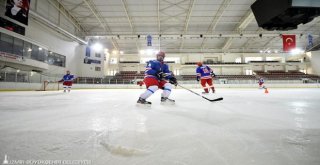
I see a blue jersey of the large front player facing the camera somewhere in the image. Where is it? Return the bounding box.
[144,60,172,79]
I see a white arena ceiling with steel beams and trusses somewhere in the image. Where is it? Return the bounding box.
[56,0,320,54]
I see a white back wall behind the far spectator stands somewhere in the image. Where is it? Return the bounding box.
[103,53,306,75]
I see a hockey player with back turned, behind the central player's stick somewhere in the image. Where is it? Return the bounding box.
[196,62,216,94]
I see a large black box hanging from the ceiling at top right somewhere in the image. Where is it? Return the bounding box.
[251,0,320,30]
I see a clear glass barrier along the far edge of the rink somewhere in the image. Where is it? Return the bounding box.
[0,70,320,84]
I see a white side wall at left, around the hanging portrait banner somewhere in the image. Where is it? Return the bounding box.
[0,0,79,74]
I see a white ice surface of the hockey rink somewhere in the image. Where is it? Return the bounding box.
[0,88,320,165]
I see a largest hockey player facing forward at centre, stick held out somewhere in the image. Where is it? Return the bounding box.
[137,51,177,104]
